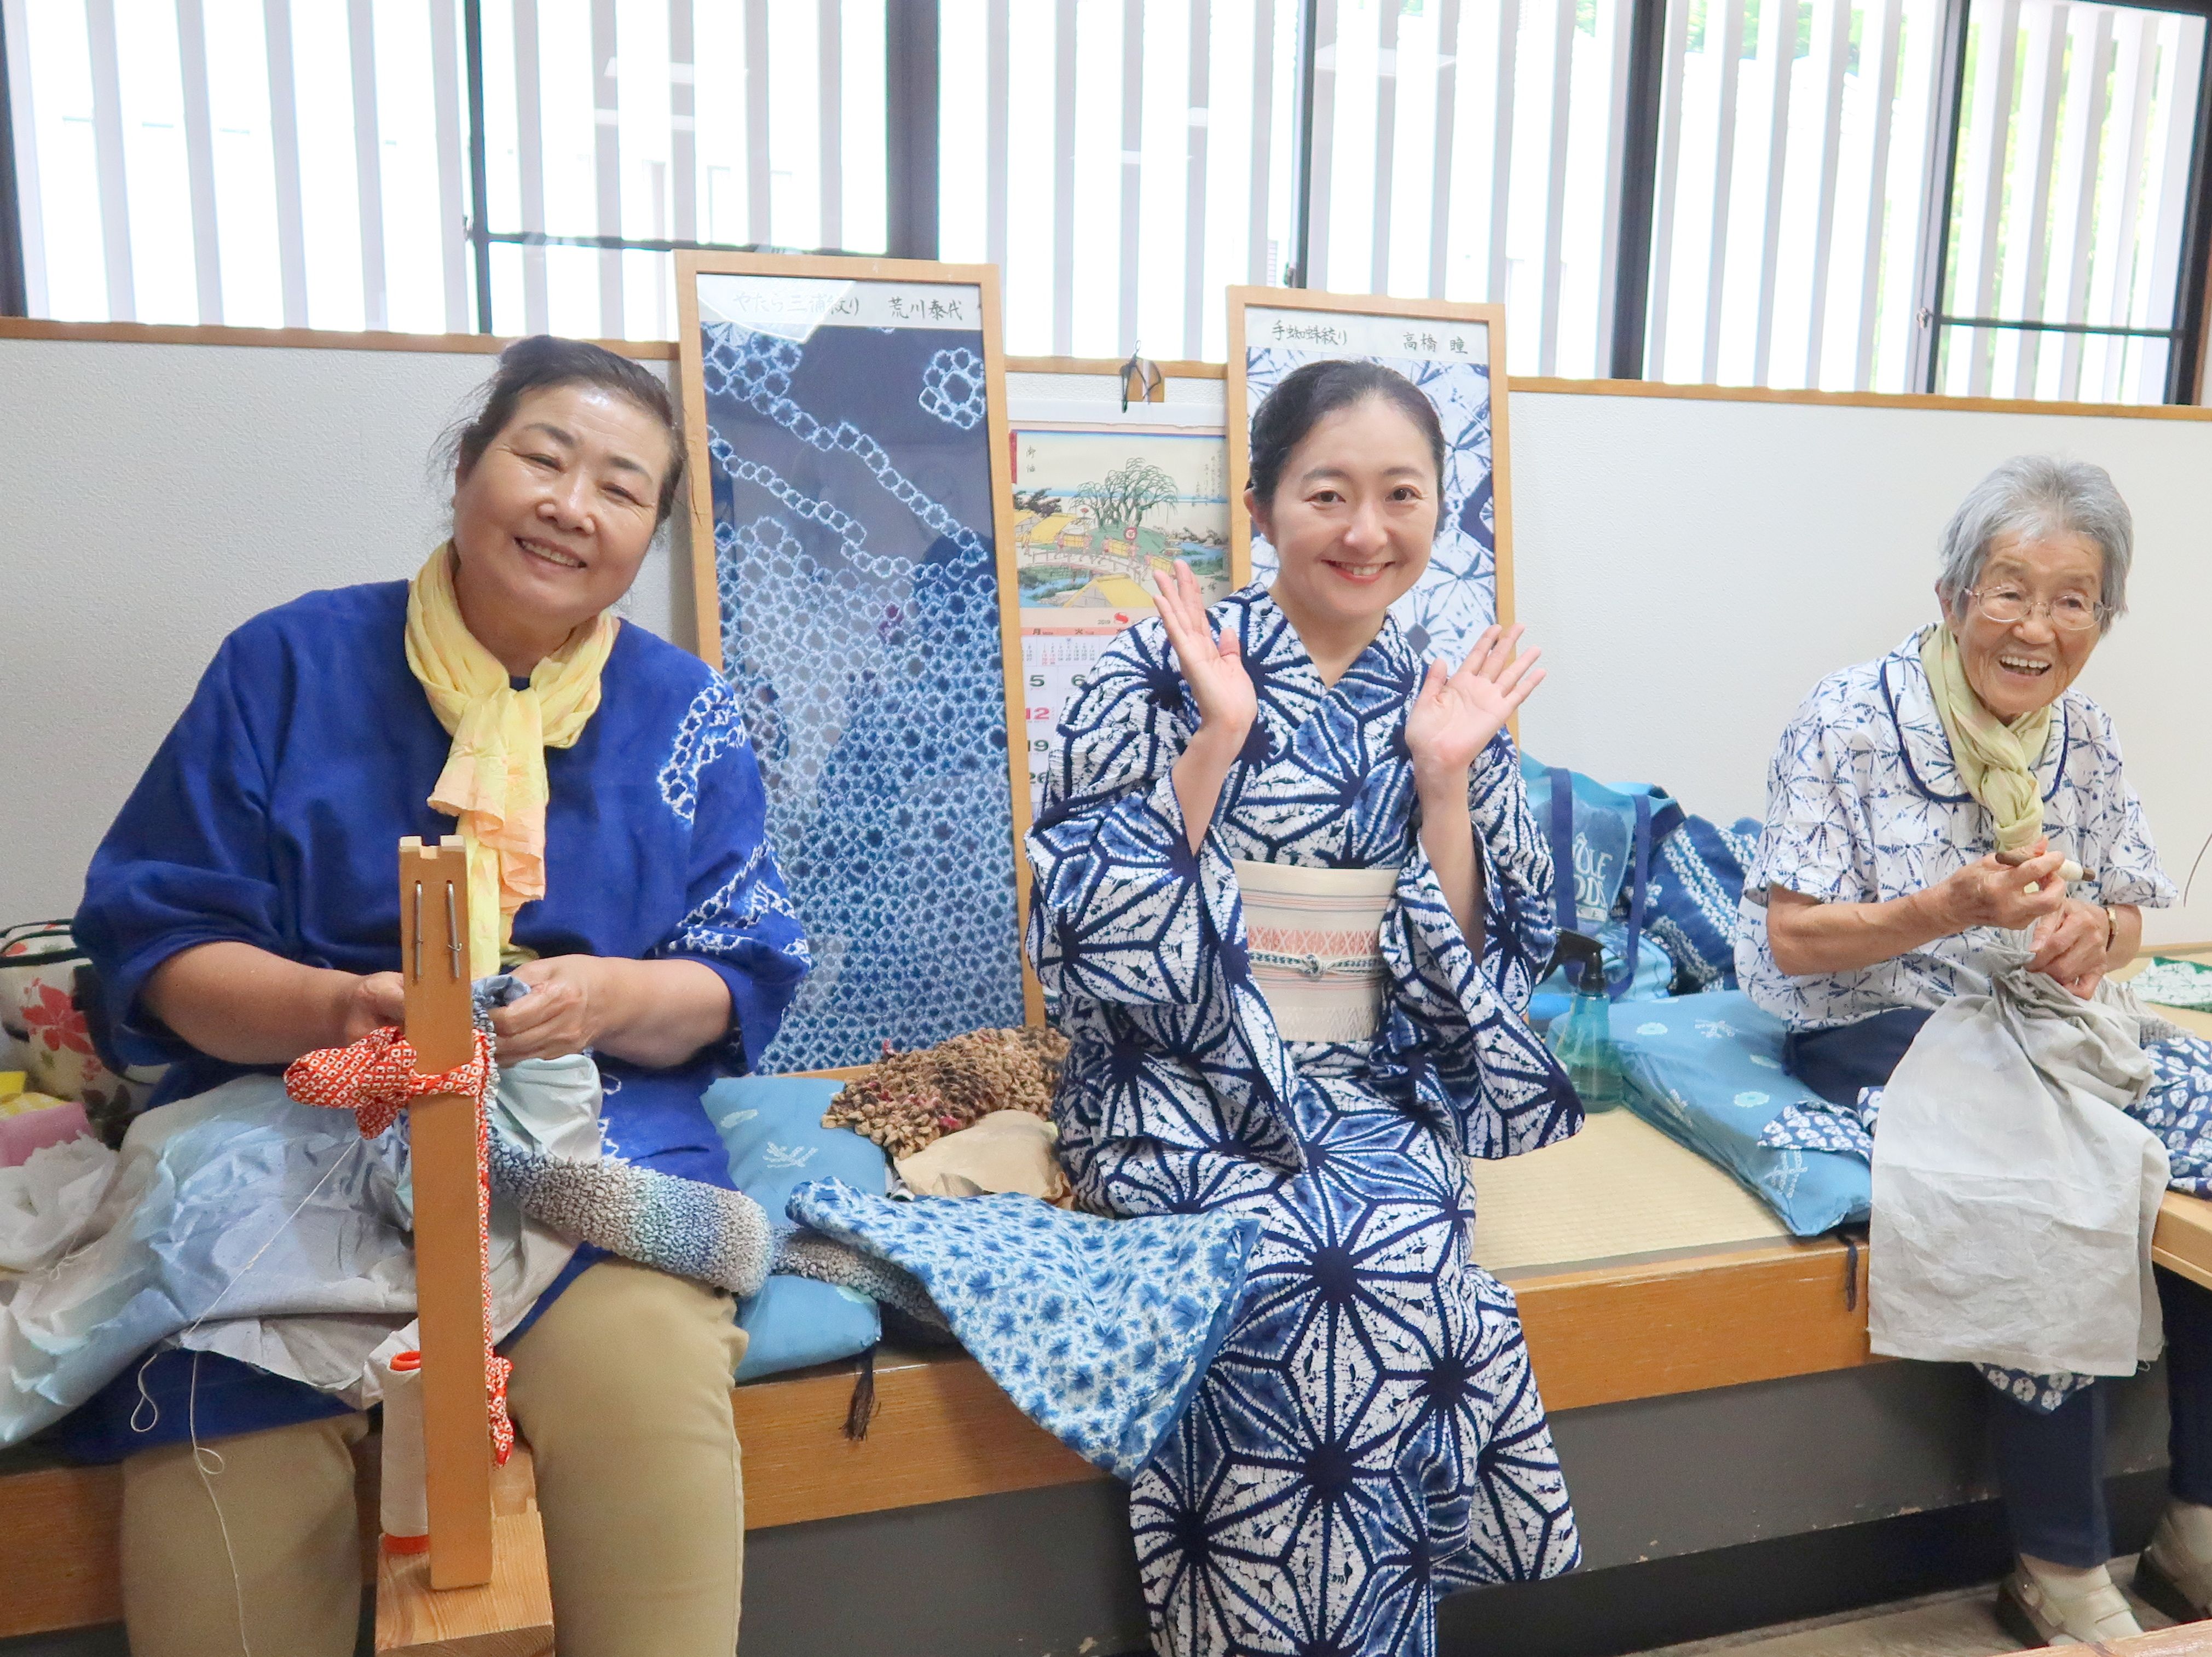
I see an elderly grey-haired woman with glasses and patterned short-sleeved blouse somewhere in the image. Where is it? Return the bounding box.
[1736,456,2212,1642]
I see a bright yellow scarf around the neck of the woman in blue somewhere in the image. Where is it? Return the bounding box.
[407,542,622,978]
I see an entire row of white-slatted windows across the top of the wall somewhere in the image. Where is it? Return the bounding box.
[0,0,2212,403]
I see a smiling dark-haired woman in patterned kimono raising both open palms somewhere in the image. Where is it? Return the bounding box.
[1029,363,1581,1657]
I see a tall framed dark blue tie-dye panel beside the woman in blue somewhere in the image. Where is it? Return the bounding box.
[677,252,1042,1071]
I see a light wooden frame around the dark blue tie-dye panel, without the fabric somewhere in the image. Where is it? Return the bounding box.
[677,252,1044,1026]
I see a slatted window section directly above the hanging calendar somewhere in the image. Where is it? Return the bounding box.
[938,0,1305,358]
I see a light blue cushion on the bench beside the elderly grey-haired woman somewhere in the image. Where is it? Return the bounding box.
[1613,989,1874,1237]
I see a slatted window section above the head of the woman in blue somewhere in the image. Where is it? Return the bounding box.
[473,0,885,339]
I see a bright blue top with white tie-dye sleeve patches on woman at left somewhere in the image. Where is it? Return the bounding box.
[77,582,807,1188]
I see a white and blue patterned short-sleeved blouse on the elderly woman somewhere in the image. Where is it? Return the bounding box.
[1736,633,2176,1029]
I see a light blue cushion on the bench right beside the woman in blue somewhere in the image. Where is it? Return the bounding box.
[703,1075,892,1381]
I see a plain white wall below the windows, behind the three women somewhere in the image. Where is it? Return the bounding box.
[0,341,2212,940]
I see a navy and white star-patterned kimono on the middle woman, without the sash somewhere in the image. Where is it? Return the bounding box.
[1029,586,1581,1657]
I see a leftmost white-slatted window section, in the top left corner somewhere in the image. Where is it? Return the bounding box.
[0,0,471,332]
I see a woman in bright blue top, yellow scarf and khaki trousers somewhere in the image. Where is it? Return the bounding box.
[73,339,805,1657]
